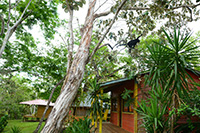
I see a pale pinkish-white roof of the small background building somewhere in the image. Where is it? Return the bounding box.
[20,99,54,106]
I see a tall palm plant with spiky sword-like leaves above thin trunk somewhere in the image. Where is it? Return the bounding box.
[142,28,200,132]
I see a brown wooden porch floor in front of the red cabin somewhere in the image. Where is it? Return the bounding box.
[92,122,130,133]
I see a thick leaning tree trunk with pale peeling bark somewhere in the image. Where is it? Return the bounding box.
[42,0,96,133]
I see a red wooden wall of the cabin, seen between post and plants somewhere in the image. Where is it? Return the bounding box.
[110,71,200,133]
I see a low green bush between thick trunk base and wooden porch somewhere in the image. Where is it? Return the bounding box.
[66,117,92,133]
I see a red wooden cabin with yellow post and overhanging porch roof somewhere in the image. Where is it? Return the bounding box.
[101,70,200,133]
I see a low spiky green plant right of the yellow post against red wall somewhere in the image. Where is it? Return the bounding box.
[137,88,173,132]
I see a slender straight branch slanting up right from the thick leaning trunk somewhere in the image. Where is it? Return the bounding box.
[86,0,127,63]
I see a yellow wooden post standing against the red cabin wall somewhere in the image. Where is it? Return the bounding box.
[134,79,138,133]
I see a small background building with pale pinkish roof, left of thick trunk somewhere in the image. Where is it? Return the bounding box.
[20,99,54,120]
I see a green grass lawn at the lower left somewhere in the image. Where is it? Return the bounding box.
[3,120,45,133]
